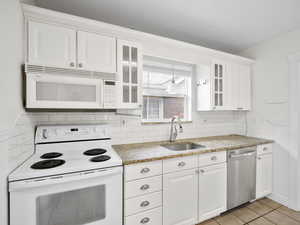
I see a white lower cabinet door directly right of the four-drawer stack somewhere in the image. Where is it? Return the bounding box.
[163,169,198,225]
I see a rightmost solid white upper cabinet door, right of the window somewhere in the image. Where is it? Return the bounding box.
[237,65,251,110]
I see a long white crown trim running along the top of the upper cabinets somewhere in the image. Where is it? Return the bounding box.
[22,4,254,64]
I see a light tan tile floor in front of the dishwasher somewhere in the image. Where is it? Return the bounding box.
[198,198,300,225]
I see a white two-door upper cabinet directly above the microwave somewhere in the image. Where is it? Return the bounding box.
[28,21,116,73]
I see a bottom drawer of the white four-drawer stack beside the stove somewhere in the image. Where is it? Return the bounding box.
[125,207,162,225]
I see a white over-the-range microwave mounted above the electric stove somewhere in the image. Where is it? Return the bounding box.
[26,71,117,109]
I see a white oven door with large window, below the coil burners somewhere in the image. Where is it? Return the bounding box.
[9,167,122,225]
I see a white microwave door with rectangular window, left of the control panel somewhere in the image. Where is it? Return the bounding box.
[26,74,103,109]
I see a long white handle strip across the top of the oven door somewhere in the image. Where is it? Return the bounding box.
[9,166,123,192]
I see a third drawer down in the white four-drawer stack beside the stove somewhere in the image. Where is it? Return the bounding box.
[125,191,162,216]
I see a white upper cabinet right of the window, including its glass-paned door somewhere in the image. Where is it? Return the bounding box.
[197,61,251,111]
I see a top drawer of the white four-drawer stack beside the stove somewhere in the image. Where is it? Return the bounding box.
[125,161,162,181]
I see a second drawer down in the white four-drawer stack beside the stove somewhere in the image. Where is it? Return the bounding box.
[125,175,162,199]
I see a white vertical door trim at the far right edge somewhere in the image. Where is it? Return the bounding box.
[288,53,300,210]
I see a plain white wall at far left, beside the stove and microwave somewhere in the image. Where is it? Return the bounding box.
[0,0,23,225]
